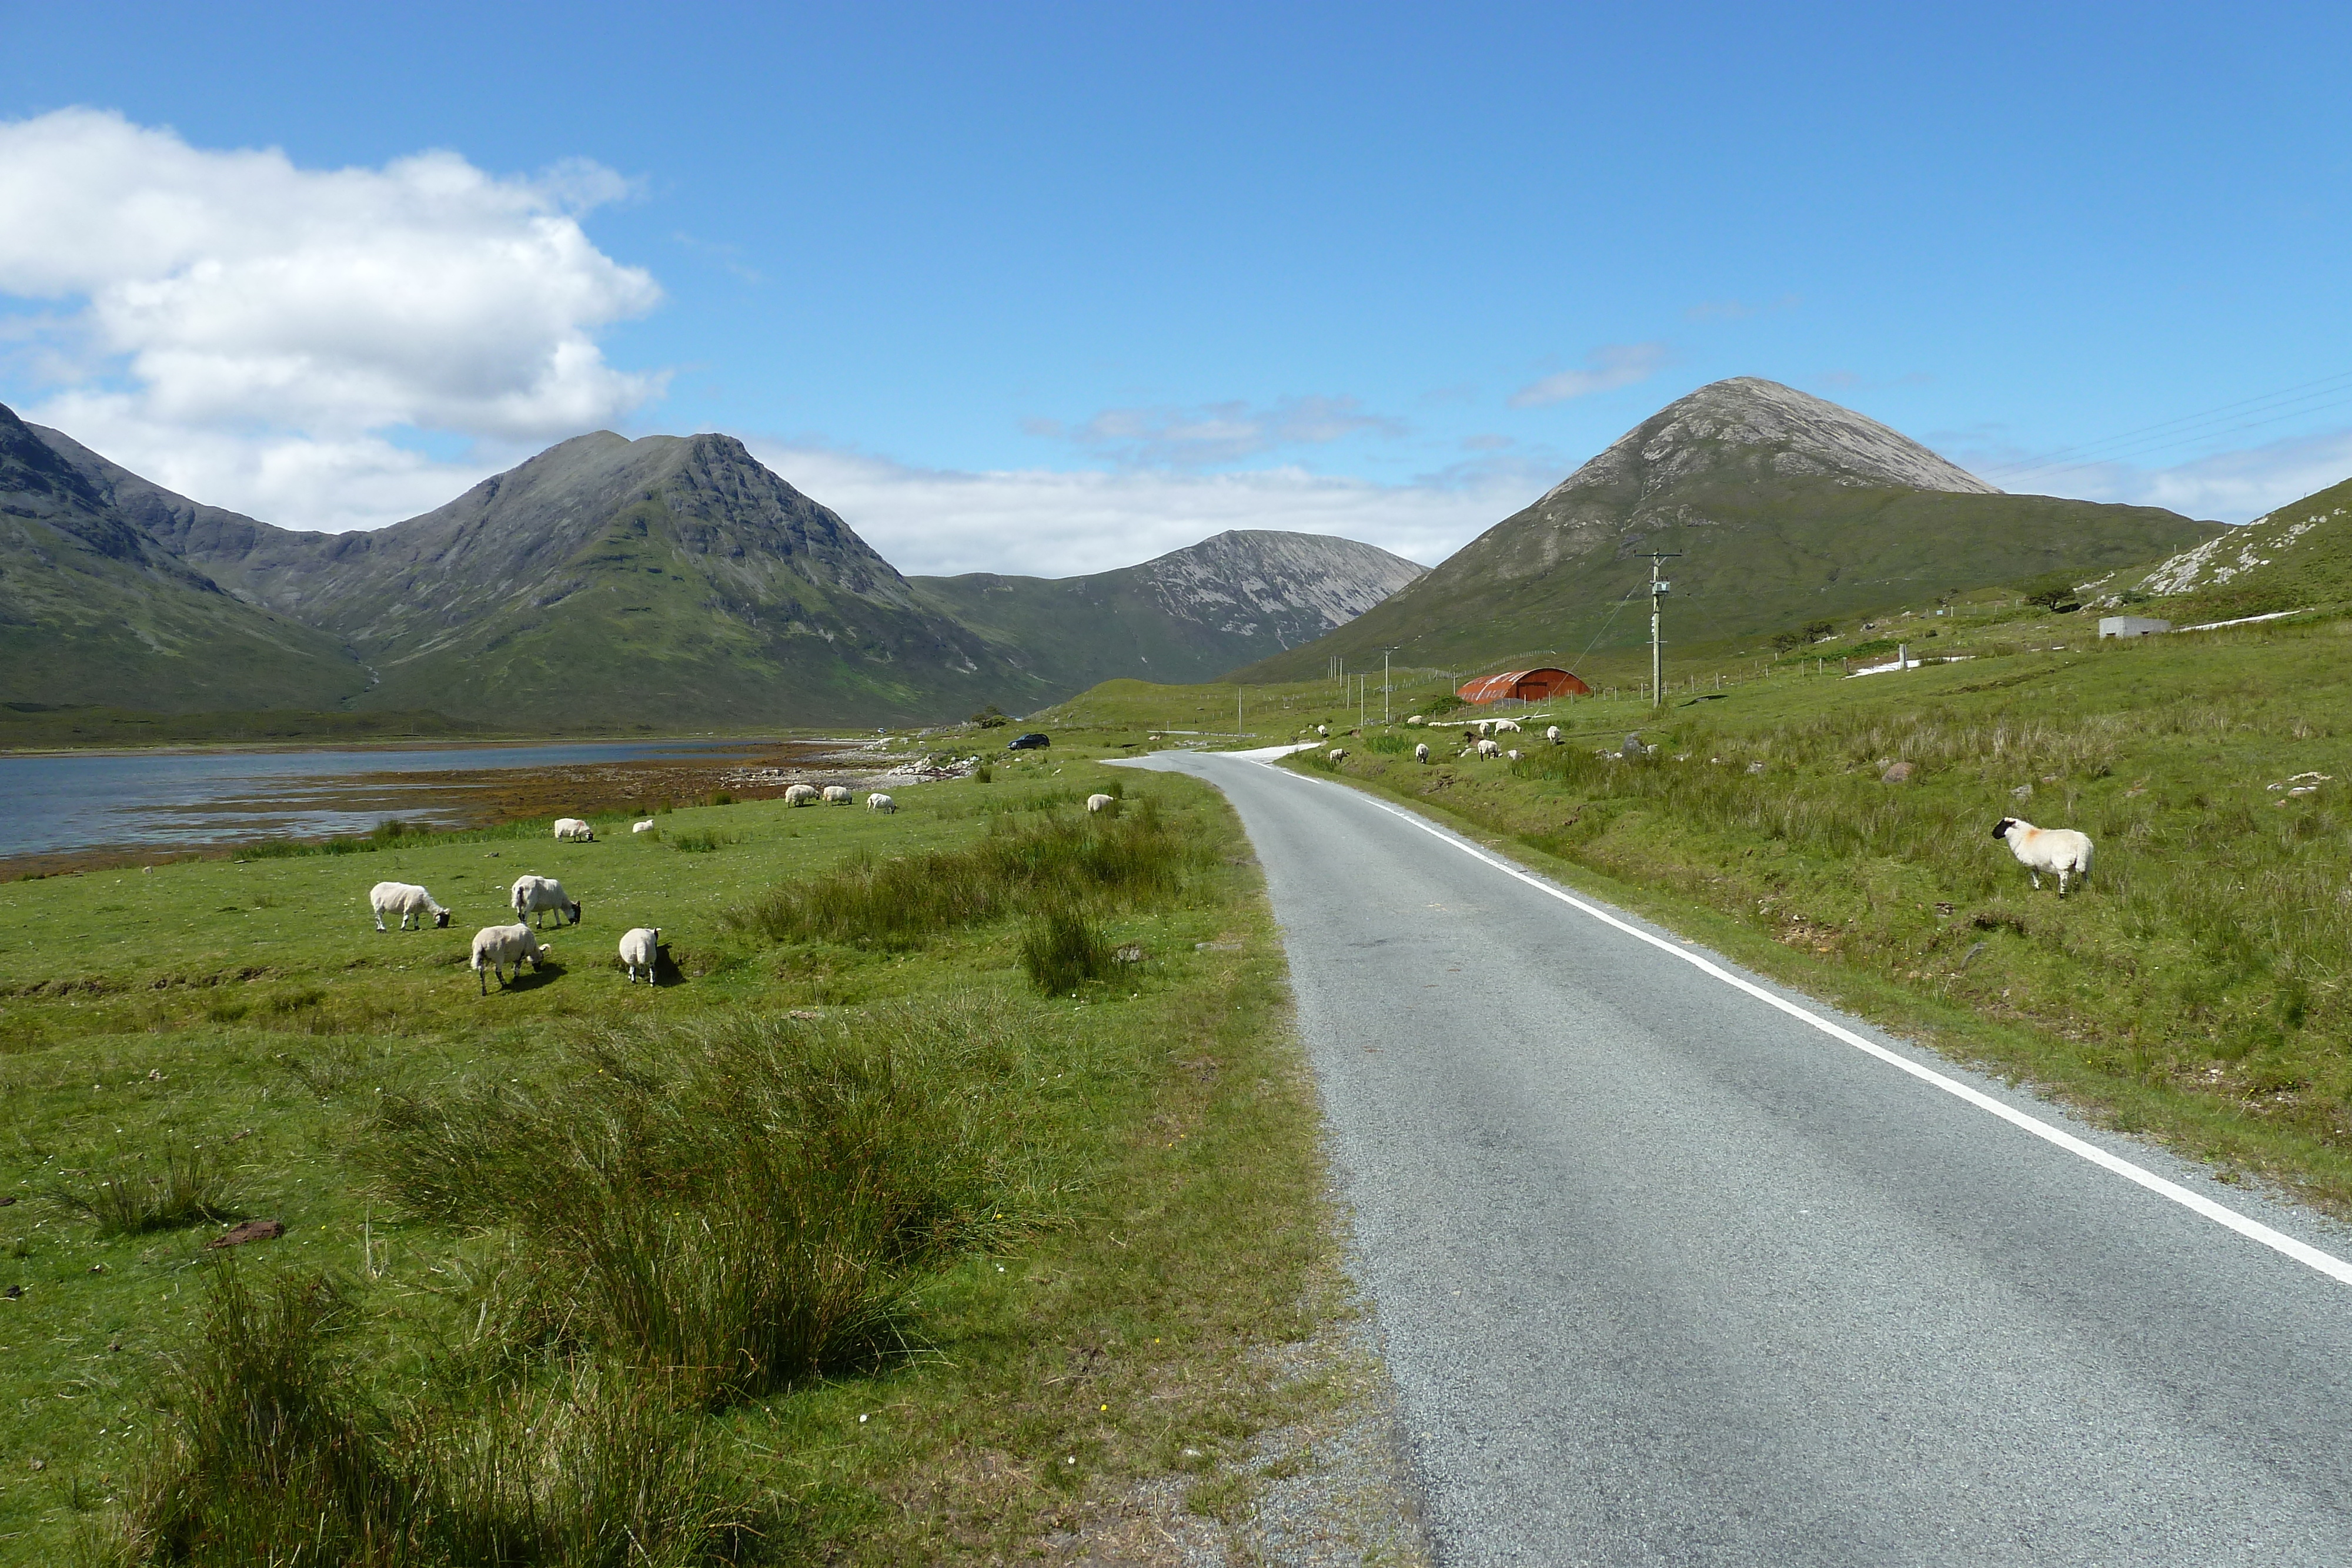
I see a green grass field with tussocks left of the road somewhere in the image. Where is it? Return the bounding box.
[0,761,1374,1563]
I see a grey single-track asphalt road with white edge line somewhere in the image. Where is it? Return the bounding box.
[1129,755,2352,1568]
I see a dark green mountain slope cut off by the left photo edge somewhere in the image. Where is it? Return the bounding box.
[0,407,367,713]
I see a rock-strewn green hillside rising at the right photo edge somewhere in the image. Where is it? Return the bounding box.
[2105,480,2352,623]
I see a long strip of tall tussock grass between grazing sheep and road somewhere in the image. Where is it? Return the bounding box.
[727,797,1200,947]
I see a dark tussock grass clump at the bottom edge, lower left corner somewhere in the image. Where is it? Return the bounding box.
[99,1262,764,1568]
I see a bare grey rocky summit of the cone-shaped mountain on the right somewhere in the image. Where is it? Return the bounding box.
[1538,376,2002,506]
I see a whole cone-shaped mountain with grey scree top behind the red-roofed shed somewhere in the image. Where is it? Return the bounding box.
[1235,376,2223,682]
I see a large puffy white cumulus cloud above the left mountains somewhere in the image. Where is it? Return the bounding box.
[0,108,661,527]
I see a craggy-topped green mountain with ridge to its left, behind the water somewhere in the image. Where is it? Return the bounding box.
[28,433,1047,729]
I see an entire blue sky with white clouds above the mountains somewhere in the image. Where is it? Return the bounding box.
[0,2,2352,574]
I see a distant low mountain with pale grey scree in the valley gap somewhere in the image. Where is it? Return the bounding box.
[908,529,1428,696]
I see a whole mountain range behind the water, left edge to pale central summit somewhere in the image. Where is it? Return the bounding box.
[0,409,1421,731]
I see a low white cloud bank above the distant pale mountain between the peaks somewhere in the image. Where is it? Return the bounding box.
[750,440,1557,576]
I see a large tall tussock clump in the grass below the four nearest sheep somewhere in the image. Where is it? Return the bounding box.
[379,1001,1018,1406]
